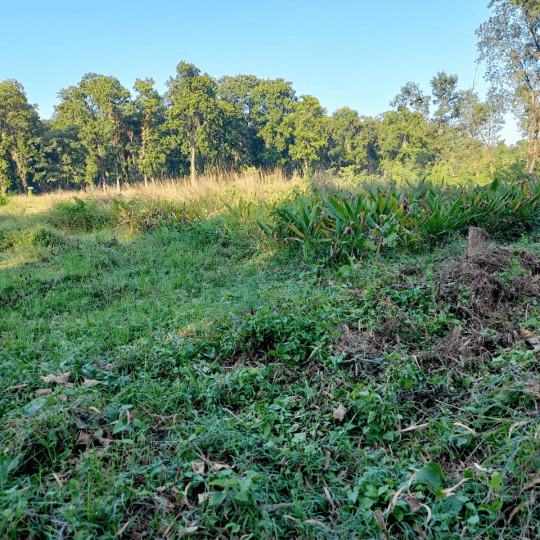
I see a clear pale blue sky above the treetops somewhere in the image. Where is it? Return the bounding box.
[0,0,521,144]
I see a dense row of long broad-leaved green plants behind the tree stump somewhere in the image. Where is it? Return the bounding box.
[259,179,540,259]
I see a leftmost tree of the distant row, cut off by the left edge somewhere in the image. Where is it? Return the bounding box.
[0,79,41,191]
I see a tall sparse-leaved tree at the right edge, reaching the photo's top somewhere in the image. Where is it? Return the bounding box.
[476,0,540,174]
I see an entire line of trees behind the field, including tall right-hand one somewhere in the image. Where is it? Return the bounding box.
[0,0,540,192]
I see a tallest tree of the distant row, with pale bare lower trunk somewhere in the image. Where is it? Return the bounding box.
[167,61,220,185]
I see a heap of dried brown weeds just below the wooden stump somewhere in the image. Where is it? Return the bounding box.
[419,248,540,364]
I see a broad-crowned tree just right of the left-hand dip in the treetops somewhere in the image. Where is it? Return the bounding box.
[55,73,130,188]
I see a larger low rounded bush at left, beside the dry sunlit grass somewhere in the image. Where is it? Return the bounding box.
[48,197,114,232]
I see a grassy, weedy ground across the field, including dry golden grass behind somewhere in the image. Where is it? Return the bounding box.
[0,177,540,540]
